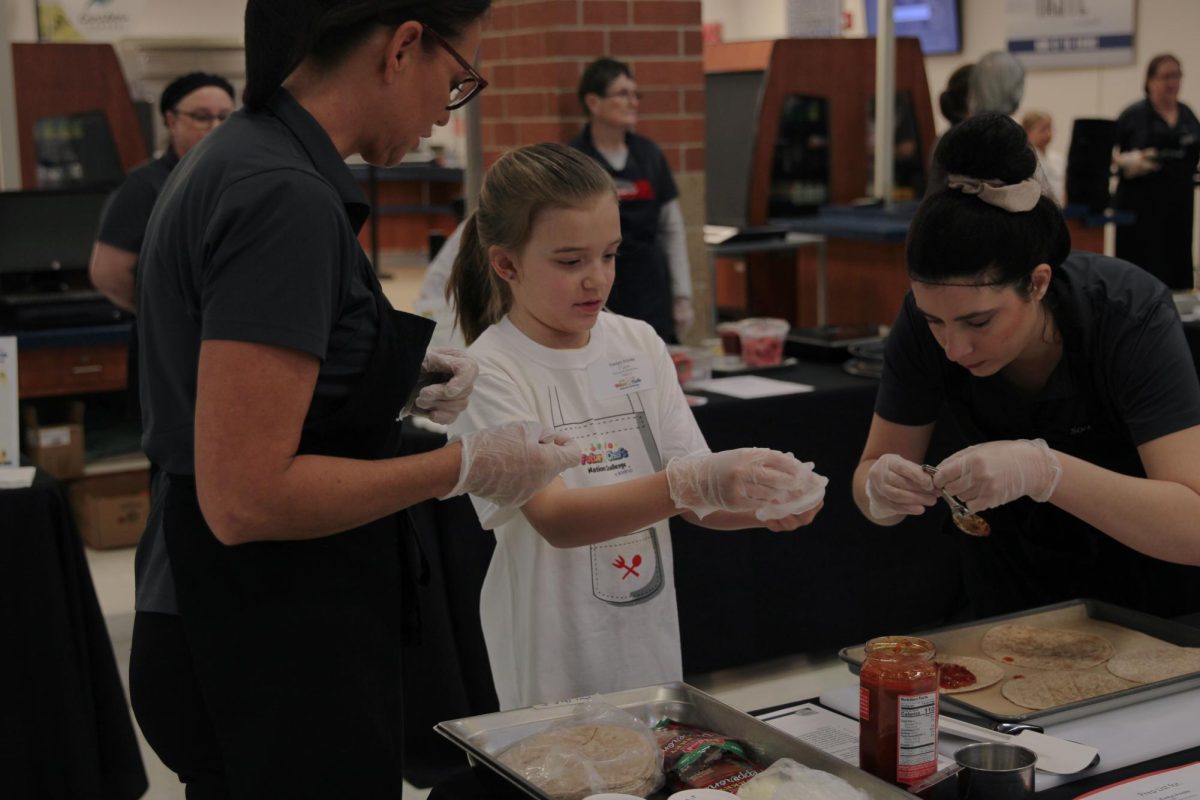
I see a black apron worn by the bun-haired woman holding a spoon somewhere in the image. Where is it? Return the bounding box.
[944,354,1200,619]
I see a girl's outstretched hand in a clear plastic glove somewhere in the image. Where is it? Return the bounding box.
[666,447,815,519]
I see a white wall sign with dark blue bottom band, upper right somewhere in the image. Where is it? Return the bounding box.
[1007,0,1136,68]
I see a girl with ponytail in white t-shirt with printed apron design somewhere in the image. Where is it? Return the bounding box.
[448,144,826,709]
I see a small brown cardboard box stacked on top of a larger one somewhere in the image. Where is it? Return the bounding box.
[68,469,150,549]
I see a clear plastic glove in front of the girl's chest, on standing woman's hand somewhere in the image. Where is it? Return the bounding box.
[440,422,583,509]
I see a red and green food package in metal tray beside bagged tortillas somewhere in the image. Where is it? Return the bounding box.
[655,720,760,793]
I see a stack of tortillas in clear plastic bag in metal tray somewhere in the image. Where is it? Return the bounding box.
[499,724,660,800]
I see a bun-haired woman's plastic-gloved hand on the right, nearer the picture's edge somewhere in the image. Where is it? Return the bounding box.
[934,439,1062,511]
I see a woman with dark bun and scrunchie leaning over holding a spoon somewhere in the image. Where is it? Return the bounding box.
[853,114,1200,615]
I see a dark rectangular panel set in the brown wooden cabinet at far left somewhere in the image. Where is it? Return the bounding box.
[34,110,125,188]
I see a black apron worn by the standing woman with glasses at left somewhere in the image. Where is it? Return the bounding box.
[163,282,433,799]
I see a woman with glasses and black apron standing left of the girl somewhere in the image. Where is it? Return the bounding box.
[130,0,580,800]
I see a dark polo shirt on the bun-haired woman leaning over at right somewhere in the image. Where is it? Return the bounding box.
[875,252,1200,476]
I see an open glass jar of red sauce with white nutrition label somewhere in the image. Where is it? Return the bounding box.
[858,636,937,786]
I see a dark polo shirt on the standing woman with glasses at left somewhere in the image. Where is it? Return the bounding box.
[138,89,378,475]
